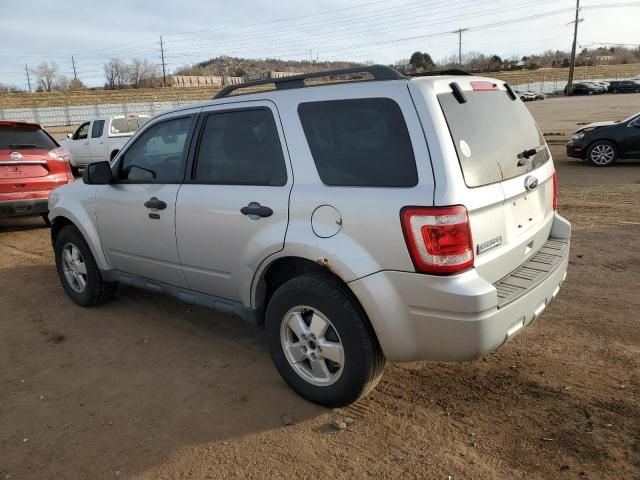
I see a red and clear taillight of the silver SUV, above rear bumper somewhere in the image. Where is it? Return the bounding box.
[400,205,474,275]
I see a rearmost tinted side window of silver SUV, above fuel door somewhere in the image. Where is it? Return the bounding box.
[298,98,418,187]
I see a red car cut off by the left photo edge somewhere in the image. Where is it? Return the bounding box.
[0,121,73,224]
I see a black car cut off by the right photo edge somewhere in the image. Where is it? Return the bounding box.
[567,113,640,167]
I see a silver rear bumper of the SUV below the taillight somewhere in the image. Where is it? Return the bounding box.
[349,215,570,362]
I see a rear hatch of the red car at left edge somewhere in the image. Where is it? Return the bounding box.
[0,122,65,194]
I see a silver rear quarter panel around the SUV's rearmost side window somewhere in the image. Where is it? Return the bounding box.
[251,81,434,305]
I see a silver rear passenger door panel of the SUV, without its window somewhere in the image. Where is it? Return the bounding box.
[176,100,293,307]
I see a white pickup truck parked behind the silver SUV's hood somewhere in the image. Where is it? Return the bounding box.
[60,114,149,176]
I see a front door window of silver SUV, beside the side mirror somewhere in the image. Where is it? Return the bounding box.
[118,117,192,183]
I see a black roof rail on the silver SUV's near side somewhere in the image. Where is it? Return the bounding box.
[213,65,406,99]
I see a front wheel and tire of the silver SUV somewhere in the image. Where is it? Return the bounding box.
[54,225,115,307]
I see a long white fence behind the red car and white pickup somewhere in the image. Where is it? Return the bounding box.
[0,100,203,127]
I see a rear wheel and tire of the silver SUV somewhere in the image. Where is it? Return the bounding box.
[265,274,385,407]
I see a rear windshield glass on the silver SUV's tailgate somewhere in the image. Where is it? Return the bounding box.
[438,90,550,187]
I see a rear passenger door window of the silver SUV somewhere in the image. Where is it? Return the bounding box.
[195,108,287,186]
